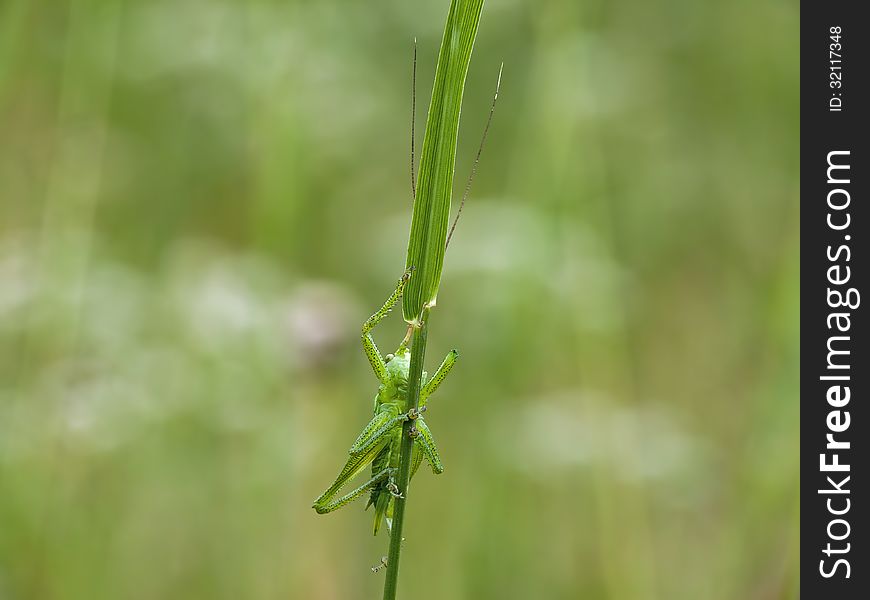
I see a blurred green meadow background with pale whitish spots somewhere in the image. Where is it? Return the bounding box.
[0,0,799,600]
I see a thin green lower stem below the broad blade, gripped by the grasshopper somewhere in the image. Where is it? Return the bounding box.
[384,308,429,600]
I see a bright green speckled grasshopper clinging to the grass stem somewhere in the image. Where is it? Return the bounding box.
[314,269,459,535]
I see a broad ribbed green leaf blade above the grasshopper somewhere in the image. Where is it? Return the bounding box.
[402,0,483,322]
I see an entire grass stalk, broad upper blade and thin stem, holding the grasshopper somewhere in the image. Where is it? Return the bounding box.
[384,0,483,600]
